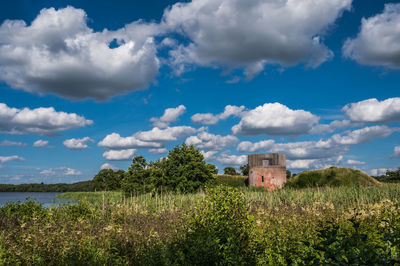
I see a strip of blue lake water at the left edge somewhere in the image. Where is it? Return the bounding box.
[0,192,71,207]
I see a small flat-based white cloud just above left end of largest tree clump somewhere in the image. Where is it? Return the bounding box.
[98,133,162,149]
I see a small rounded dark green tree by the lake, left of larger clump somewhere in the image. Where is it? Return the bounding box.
[92,169,125,190]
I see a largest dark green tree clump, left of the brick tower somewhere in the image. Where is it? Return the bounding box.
[122,143,213,193]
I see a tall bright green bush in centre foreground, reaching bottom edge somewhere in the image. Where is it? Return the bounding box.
[174,186,255,265]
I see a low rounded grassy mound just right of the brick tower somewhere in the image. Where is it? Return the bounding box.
[286,167,379,188]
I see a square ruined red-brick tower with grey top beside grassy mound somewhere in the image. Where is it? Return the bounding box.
[248,153,286,190]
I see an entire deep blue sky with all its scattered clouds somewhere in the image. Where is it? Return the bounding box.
[0,0,400,184]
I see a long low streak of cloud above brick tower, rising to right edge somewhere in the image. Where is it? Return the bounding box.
[237,126,399,160]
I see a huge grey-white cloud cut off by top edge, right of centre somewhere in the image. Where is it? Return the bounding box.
[163,0,352,78]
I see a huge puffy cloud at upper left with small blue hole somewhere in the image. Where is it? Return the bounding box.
[0,6,161,101]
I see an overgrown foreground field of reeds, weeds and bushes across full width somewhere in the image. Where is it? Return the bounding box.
[0,184,400,265]
